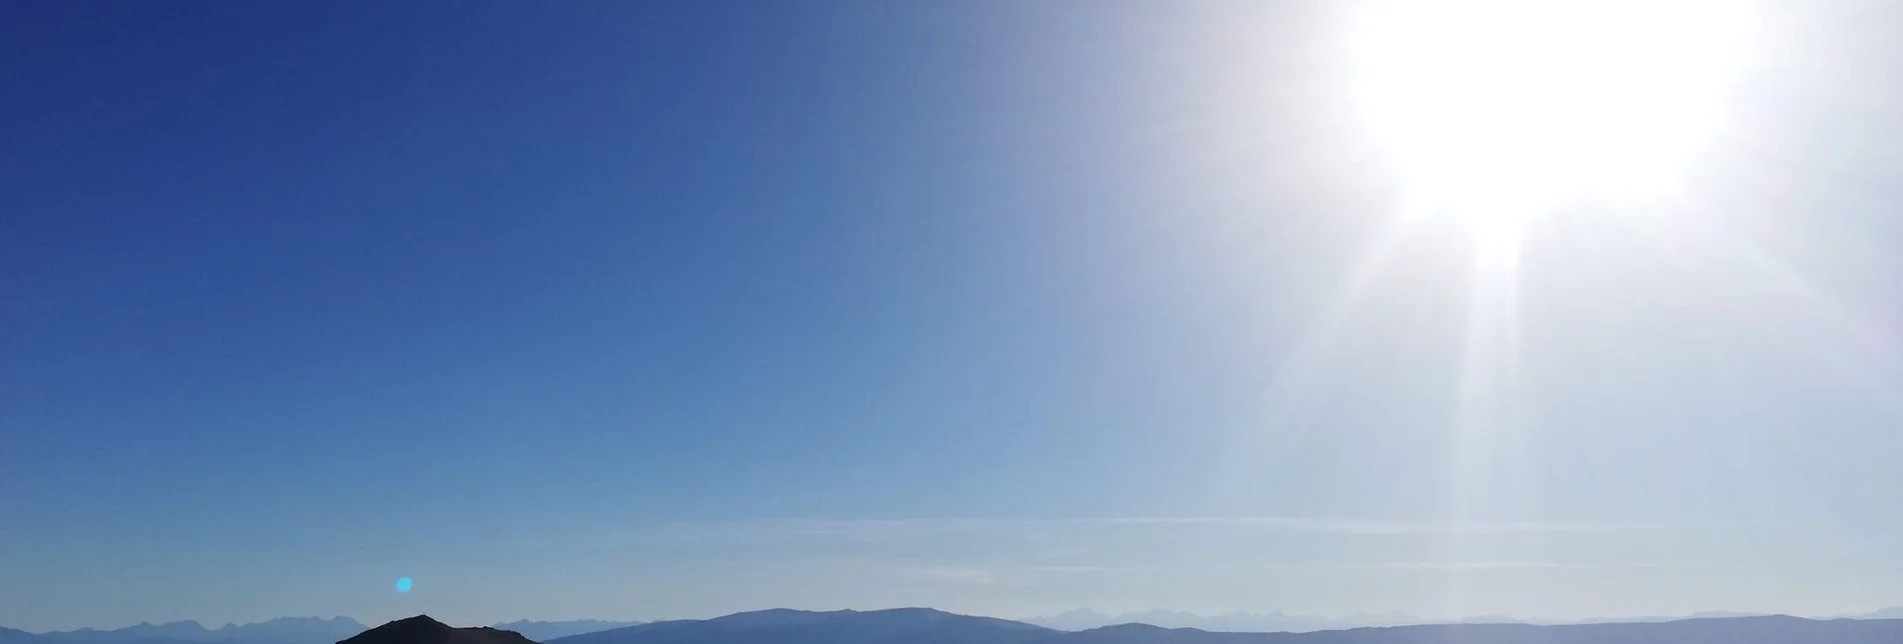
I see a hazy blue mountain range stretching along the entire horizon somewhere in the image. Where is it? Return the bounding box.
[11,608,1903,644]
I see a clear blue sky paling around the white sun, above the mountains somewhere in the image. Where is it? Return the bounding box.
[0,0,1903,631]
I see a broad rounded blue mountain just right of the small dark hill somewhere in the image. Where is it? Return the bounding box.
[554,608,1056,644]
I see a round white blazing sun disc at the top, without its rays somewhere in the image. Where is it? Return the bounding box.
[1355,0,1747,234]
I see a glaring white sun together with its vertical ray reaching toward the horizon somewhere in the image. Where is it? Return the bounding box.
[1353,0,1751,586]
